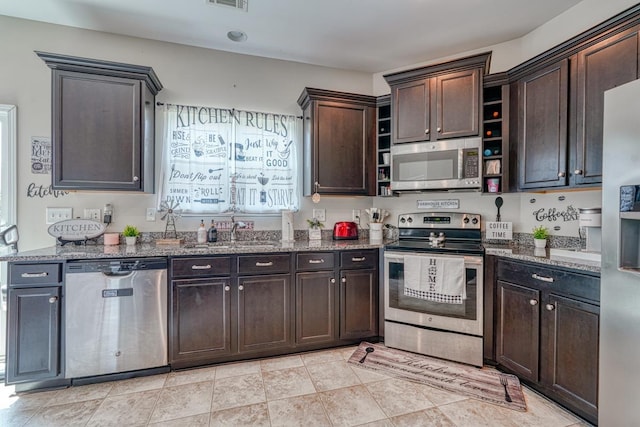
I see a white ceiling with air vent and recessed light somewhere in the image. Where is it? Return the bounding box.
[0,0,580,73]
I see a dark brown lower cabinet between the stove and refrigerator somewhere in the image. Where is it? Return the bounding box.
[494,259,600,424]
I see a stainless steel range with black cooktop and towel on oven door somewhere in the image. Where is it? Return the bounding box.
[384,212,484,366]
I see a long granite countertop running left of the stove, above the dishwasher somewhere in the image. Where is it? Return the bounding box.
[0,239,387,262]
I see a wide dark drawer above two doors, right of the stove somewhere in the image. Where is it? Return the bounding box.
[497,260,600,303]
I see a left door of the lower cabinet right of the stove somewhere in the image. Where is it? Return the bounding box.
[495,280,540,382]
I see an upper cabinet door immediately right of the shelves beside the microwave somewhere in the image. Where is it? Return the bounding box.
[518,60,569,189]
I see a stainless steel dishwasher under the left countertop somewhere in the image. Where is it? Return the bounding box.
[65,258,168,378]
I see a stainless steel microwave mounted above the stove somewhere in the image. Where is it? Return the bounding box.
[391,138,482,191]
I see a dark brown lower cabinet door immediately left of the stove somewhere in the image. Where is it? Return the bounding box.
[340,269,378,339]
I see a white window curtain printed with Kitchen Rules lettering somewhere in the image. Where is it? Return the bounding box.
[159,105,299,213]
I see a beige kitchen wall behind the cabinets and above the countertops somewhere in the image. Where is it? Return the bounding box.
[0,0,634,250]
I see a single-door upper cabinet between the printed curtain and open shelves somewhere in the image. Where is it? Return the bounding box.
[298,88,376,196]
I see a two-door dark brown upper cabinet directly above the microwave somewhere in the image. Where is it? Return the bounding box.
[384,53,491,144]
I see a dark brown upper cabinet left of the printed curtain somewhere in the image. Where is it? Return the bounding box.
[36,52,162,193]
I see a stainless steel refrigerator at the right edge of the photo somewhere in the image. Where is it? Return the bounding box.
[604,77,640,426]
